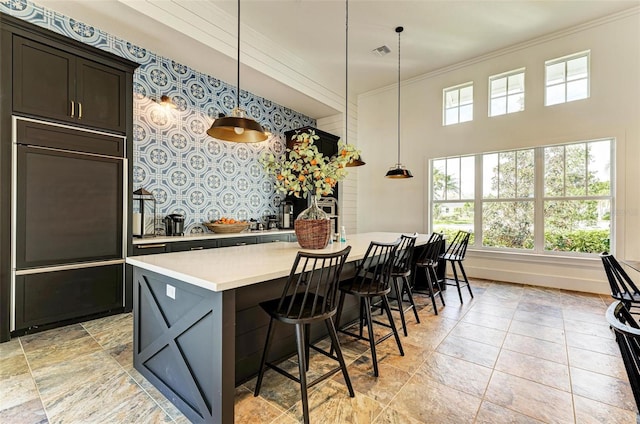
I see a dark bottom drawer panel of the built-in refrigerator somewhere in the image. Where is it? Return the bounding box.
[15,264,124,332]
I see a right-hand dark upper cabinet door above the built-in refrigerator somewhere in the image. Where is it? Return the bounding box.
[75,58,127,132]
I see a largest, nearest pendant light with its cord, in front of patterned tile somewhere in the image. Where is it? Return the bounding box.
[207,0,268,143]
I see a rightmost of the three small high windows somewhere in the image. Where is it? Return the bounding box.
[544,51,589,106]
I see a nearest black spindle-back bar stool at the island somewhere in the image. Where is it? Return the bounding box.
[254,246,355,424]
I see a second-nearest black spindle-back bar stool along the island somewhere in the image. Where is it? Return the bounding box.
[336,239,404,377]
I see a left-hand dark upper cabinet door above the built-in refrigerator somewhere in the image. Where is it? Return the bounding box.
[13,36,75,122]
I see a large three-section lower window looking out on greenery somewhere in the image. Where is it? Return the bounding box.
[431,139,614,254]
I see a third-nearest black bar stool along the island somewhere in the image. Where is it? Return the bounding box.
[384,233,420,336]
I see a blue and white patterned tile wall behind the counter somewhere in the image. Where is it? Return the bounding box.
[0,0,316,233]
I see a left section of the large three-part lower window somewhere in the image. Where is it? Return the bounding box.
[431,156,475,242]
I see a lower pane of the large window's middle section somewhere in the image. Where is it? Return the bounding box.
[482,201,533,250]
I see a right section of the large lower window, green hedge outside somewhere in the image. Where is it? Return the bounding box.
[544,140,611,253]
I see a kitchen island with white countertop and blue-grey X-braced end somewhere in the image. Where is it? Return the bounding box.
[127,233,427,424]
